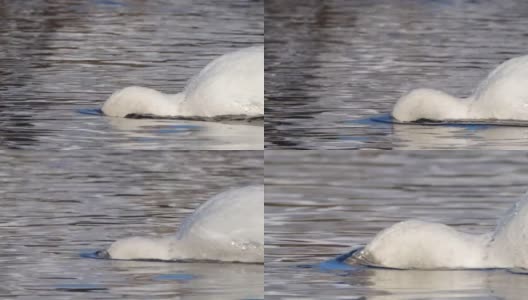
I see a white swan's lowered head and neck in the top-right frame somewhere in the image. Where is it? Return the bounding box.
[392,89,469,122]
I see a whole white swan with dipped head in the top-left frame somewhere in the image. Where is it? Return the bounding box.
[101,46,264,117]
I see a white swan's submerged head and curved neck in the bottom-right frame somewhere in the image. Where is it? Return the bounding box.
[353,220,490,269]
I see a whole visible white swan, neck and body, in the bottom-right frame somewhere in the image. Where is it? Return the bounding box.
[350,194,528,269]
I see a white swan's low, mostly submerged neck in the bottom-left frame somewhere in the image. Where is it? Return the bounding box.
[105,237,170,260]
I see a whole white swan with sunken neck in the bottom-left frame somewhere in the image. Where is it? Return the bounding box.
[96,185,264,263]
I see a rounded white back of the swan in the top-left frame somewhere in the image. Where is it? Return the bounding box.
[184,46,264,116]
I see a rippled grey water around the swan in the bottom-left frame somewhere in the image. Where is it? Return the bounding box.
[0,150,264,299]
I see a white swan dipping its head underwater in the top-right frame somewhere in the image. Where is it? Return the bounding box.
[392,55,528,122]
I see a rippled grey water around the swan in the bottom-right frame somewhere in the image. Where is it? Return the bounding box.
[265,151,528,300]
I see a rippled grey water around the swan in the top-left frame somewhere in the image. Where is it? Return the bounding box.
[0,0,264,151]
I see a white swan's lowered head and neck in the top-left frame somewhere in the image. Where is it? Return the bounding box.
[101,86,184,117]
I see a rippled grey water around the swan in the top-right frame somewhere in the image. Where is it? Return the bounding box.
[265,0,528,149]
